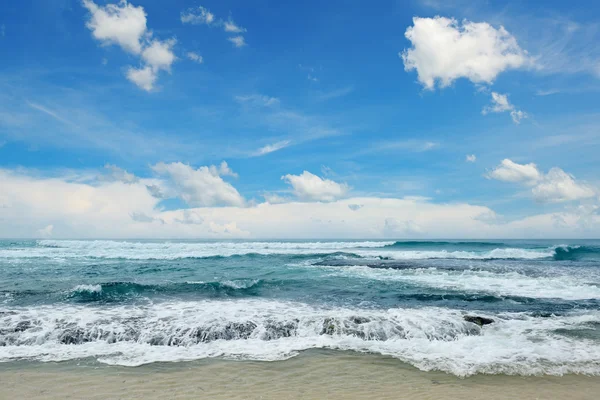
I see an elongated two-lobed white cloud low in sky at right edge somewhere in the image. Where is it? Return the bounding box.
[488,159,596,203]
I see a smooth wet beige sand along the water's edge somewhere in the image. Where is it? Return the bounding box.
[0,351,600,400]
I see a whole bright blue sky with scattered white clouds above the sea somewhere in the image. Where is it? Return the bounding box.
[0,0,600,239]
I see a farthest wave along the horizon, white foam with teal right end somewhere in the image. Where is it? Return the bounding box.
[0,240,600,261]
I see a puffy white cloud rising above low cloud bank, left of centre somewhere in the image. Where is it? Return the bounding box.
[152,162,245,206]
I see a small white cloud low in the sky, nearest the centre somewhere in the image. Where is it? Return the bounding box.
[281,171,350,201]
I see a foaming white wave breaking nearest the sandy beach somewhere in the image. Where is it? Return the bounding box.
[0,300,600,376]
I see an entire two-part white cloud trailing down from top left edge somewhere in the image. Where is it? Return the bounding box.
[83,0,177,92]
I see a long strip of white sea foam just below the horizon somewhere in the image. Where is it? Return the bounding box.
[0,240,555,260]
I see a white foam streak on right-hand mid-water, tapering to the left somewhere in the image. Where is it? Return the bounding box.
[310,265,600,300]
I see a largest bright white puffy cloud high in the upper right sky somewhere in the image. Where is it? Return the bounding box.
[400,17,532,90]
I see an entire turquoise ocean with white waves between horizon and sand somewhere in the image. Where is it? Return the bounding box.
[0,240,600,377]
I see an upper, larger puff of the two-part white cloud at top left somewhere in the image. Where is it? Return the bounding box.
[83,0,146,54]
